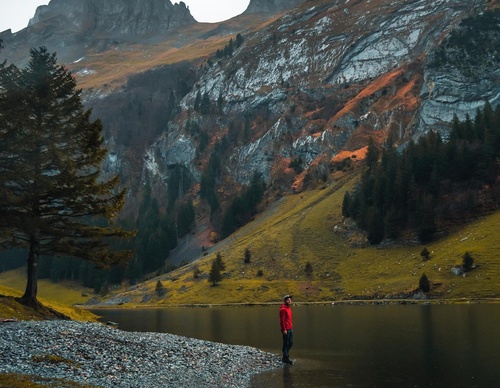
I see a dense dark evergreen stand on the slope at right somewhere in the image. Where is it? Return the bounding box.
[342,103,500,244]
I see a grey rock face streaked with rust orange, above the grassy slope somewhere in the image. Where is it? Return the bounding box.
[147,0,492,191]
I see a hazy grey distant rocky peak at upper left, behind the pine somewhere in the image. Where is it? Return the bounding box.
[1,0,196,62]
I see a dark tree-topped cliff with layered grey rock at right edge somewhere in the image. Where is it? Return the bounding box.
[417,9,500,136]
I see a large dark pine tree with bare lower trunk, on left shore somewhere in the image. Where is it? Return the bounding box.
[0,47,131,305]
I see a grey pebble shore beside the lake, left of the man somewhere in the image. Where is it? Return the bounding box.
[0,321,282,388]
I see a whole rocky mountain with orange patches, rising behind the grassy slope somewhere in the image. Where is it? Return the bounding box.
[0,0,500,296]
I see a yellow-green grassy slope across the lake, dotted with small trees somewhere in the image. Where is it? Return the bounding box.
[95,174,500,306]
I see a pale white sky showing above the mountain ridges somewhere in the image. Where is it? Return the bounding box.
[0,0,250,32]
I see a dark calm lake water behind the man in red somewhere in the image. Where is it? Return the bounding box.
[90,304,500,388]
